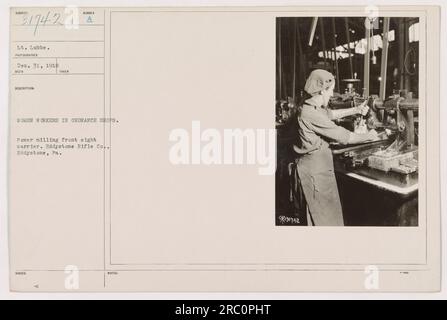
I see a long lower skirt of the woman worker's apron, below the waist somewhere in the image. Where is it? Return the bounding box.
[296,145,344,226]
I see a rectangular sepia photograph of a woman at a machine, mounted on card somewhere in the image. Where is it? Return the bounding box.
[275,16,423,227]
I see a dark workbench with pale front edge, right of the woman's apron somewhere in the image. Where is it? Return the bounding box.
[334,152,418,226]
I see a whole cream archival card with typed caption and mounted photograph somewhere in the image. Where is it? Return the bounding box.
[8,6,441,292]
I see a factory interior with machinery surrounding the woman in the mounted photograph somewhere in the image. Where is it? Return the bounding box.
[275,17,423,226]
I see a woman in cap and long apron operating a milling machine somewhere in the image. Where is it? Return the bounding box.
[293,69,377,226]
